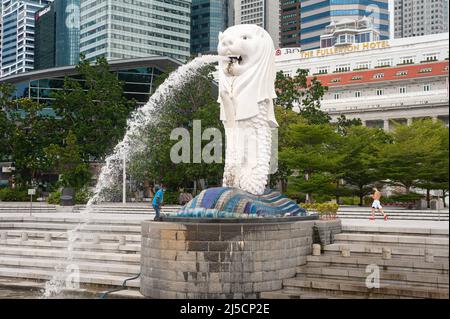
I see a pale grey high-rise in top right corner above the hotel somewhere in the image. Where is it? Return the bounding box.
[394,0,448,38]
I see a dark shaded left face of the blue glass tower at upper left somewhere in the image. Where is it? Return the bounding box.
[34,3,56,70]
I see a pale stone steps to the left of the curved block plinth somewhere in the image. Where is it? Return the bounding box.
[0,213,146,298]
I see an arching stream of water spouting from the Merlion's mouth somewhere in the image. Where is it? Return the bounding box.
[42,55,219,298]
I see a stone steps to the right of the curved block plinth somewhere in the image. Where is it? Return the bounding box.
[268,221,449,299]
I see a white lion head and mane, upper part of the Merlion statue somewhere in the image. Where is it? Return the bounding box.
[217,24,277,126]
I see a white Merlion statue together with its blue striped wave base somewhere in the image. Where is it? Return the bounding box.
[171,24,307,218]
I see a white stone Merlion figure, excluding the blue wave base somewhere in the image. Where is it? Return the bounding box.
[217,24,278,195]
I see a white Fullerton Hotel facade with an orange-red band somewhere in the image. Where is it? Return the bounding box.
[276,33,449,130]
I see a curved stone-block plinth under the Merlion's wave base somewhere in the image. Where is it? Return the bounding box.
[141,217,314,299]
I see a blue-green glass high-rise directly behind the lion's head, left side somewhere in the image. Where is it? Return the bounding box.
[191,0,229,54]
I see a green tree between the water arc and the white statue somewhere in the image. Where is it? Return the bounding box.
[130,66,224,194]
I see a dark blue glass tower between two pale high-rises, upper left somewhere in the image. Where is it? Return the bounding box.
[34,0,80,69]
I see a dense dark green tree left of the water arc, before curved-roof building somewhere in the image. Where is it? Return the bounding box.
[52,57,136,161]
